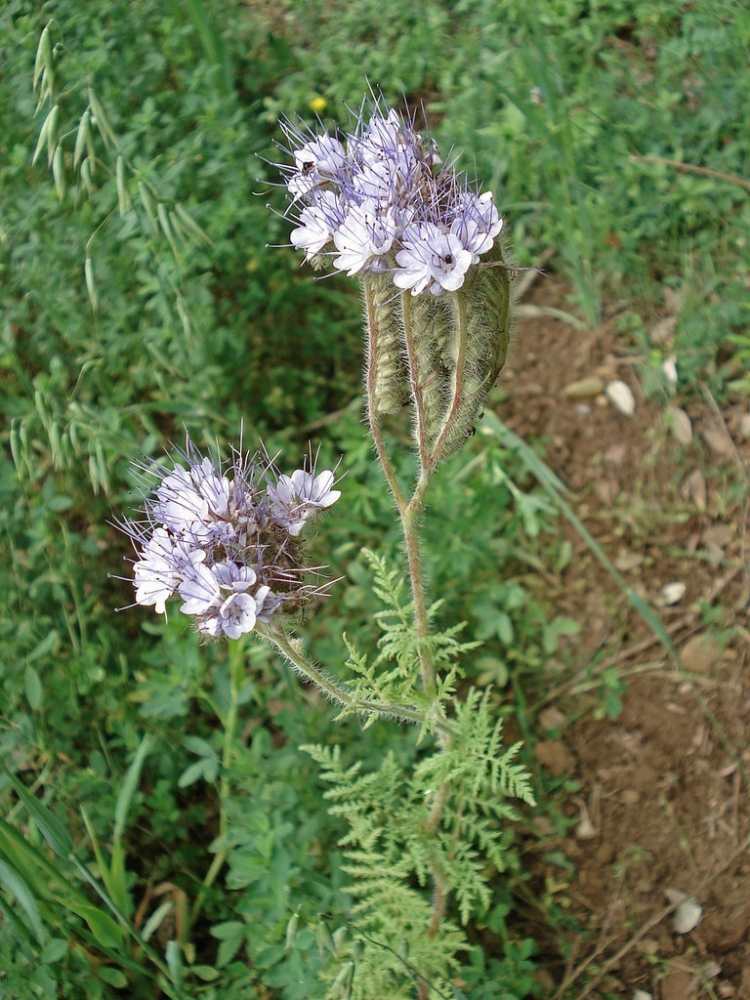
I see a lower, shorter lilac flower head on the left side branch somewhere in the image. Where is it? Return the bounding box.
[118,441,341,639]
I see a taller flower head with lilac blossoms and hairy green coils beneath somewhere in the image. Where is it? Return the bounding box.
[280,101,510,464]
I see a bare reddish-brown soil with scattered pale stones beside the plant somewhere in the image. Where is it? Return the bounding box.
[501,277,750,1000]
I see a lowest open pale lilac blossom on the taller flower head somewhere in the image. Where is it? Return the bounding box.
[393,222,474,295]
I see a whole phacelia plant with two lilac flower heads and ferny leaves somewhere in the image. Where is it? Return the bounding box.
[114,103,533,1000]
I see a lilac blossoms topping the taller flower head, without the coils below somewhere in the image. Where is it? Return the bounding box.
[280,107,503,295]
